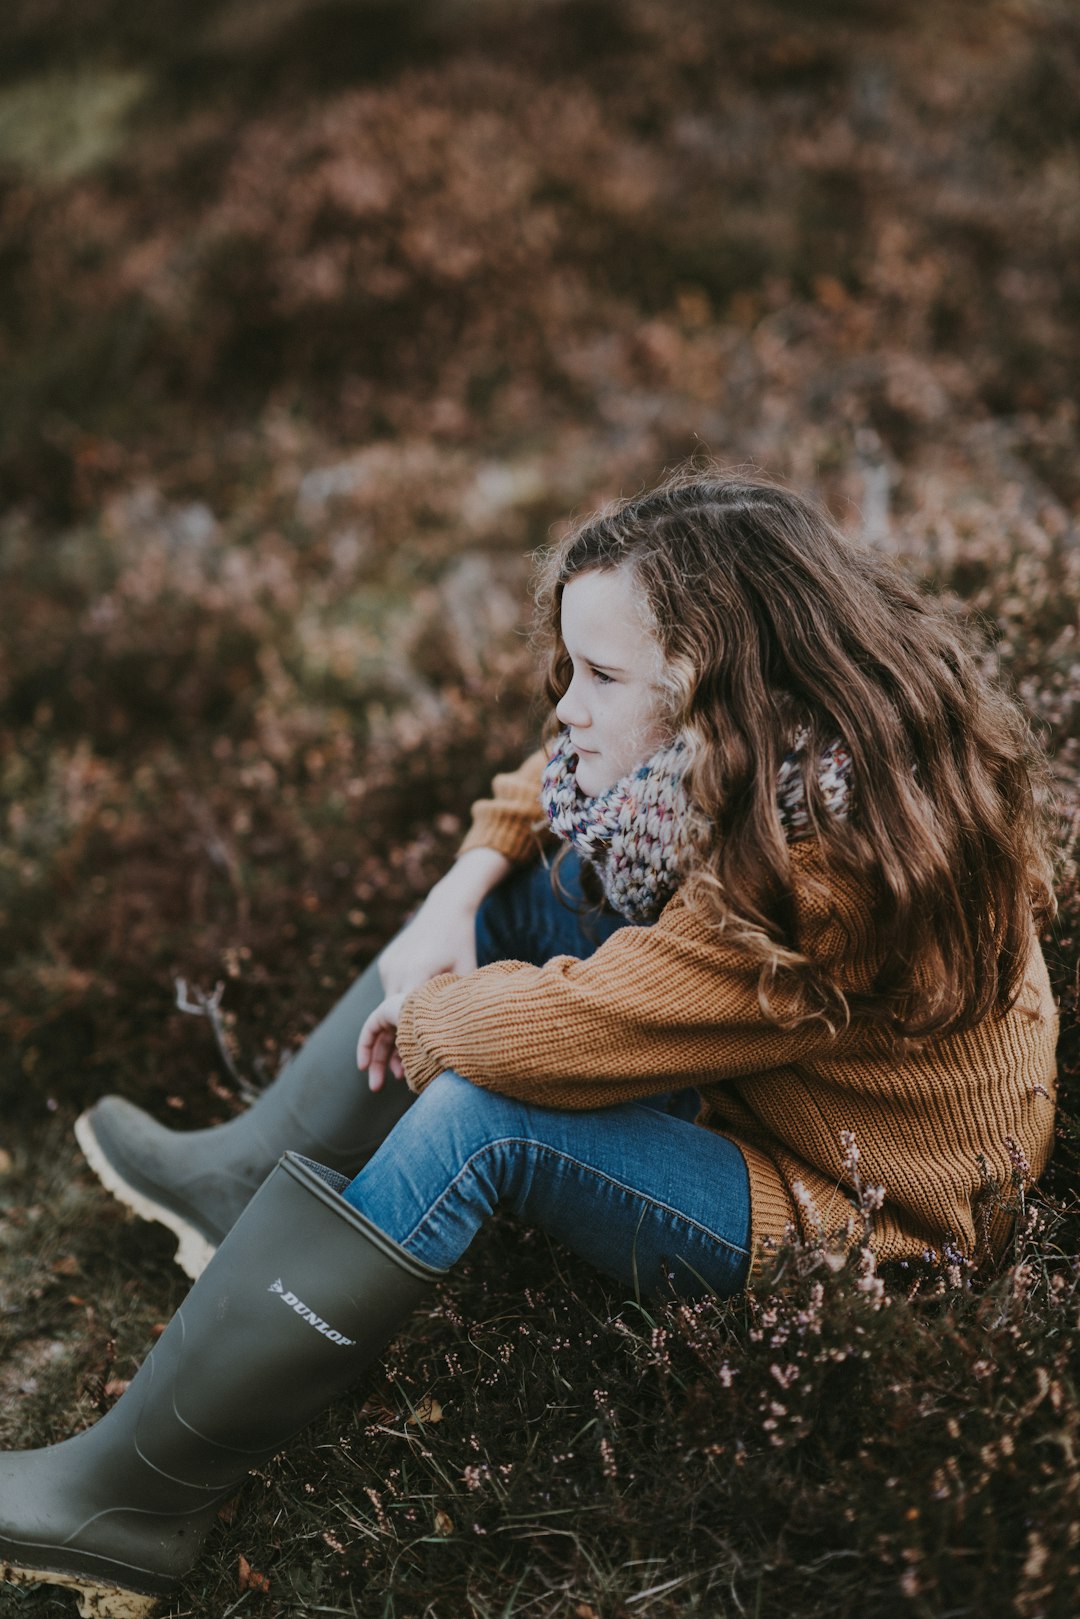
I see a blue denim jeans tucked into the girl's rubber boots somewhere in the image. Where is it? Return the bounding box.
[345,861,750,1297]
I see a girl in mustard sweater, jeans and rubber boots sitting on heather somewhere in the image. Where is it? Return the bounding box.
[0,474,1056,1619]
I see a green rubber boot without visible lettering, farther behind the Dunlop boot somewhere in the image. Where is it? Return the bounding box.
[74,962,413,1279]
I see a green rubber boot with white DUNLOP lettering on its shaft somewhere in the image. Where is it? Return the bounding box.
[0,1153,440,1619]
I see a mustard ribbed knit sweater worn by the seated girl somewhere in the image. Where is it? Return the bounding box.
[398,753,1057,1260]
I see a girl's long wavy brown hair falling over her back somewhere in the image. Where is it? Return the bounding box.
[536,468,1054,1041]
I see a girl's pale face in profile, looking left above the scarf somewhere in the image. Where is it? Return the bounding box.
[555,568,667,798]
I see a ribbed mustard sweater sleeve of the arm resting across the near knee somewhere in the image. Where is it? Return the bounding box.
[397,897,852,1107]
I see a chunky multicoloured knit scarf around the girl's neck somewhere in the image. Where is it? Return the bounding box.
[541,729,852,923]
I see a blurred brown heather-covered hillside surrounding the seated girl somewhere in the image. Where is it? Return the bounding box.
[0,0,1080,1619]
